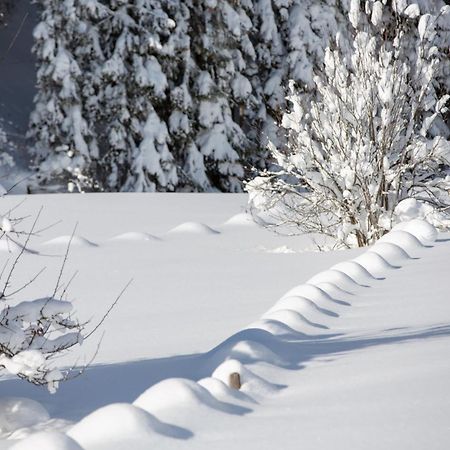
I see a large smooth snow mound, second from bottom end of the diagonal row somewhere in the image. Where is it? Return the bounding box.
[67,403,190,448]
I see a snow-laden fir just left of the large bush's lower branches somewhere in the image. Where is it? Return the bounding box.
[189,0,253,192]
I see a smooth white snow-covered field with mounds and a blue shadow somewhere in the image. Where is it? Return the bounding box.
[0,194,450,450]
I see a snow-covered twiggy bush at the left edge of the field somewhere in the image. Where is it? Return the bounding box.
[0,214,84,392]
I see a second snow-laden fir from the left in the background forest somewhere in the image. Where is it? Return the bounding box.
[96,0,178,191]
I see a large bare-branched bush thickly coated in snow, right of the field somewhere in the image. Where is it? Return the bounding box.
[248,1,450,246]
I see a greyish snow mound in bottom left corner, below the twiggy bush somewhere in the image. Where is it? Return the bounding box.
[0,397,50,436]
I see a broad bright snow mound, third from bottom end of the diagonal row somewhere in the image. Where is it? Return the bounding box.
[133,378,238,415]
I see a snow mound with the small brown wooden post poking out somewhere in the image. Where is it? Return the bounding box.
[212,359,282,401]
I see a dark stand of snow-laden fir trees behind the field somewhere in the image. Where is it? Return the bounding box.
[25,0,450,192]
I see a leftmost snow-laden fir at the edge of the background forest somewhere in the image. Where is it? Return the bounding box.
[29,0,108,190]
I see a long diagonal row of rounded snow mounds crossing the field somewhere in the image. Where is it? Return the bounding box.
[0,219,437,450]
